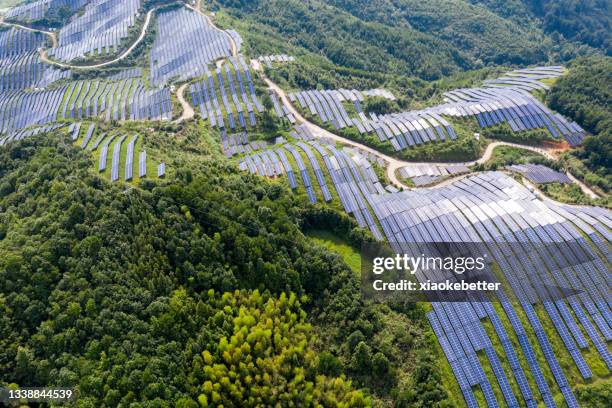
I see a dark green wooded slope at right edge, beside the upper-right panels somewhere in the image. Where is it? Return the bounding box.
[547,57,612,191]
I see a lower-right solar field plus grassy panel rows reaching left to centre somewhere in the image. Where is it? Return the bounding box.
[240,135,612,407]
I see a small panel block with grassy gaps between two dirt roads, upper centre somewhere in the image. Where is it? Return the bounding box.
[189,56,264,130]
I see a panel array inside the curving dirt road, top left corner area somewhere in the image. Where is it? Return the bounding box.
[48,0,141,61]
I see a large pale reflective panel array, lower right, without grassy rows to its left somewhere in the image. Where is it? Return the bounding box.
[372,172,612,407]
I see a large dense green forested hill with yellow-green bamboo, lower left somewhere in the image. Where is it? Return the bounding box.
[0,132,450,407]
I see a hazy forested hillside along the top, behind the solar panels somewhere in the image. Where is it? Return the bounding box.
[216,0,584,80]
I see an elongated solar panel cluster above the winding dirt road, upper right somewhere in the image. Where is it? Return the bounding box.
[289,67,585,151]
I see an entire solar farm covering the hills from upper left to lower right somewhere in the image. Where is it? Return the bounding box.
[0,0,612,408]
